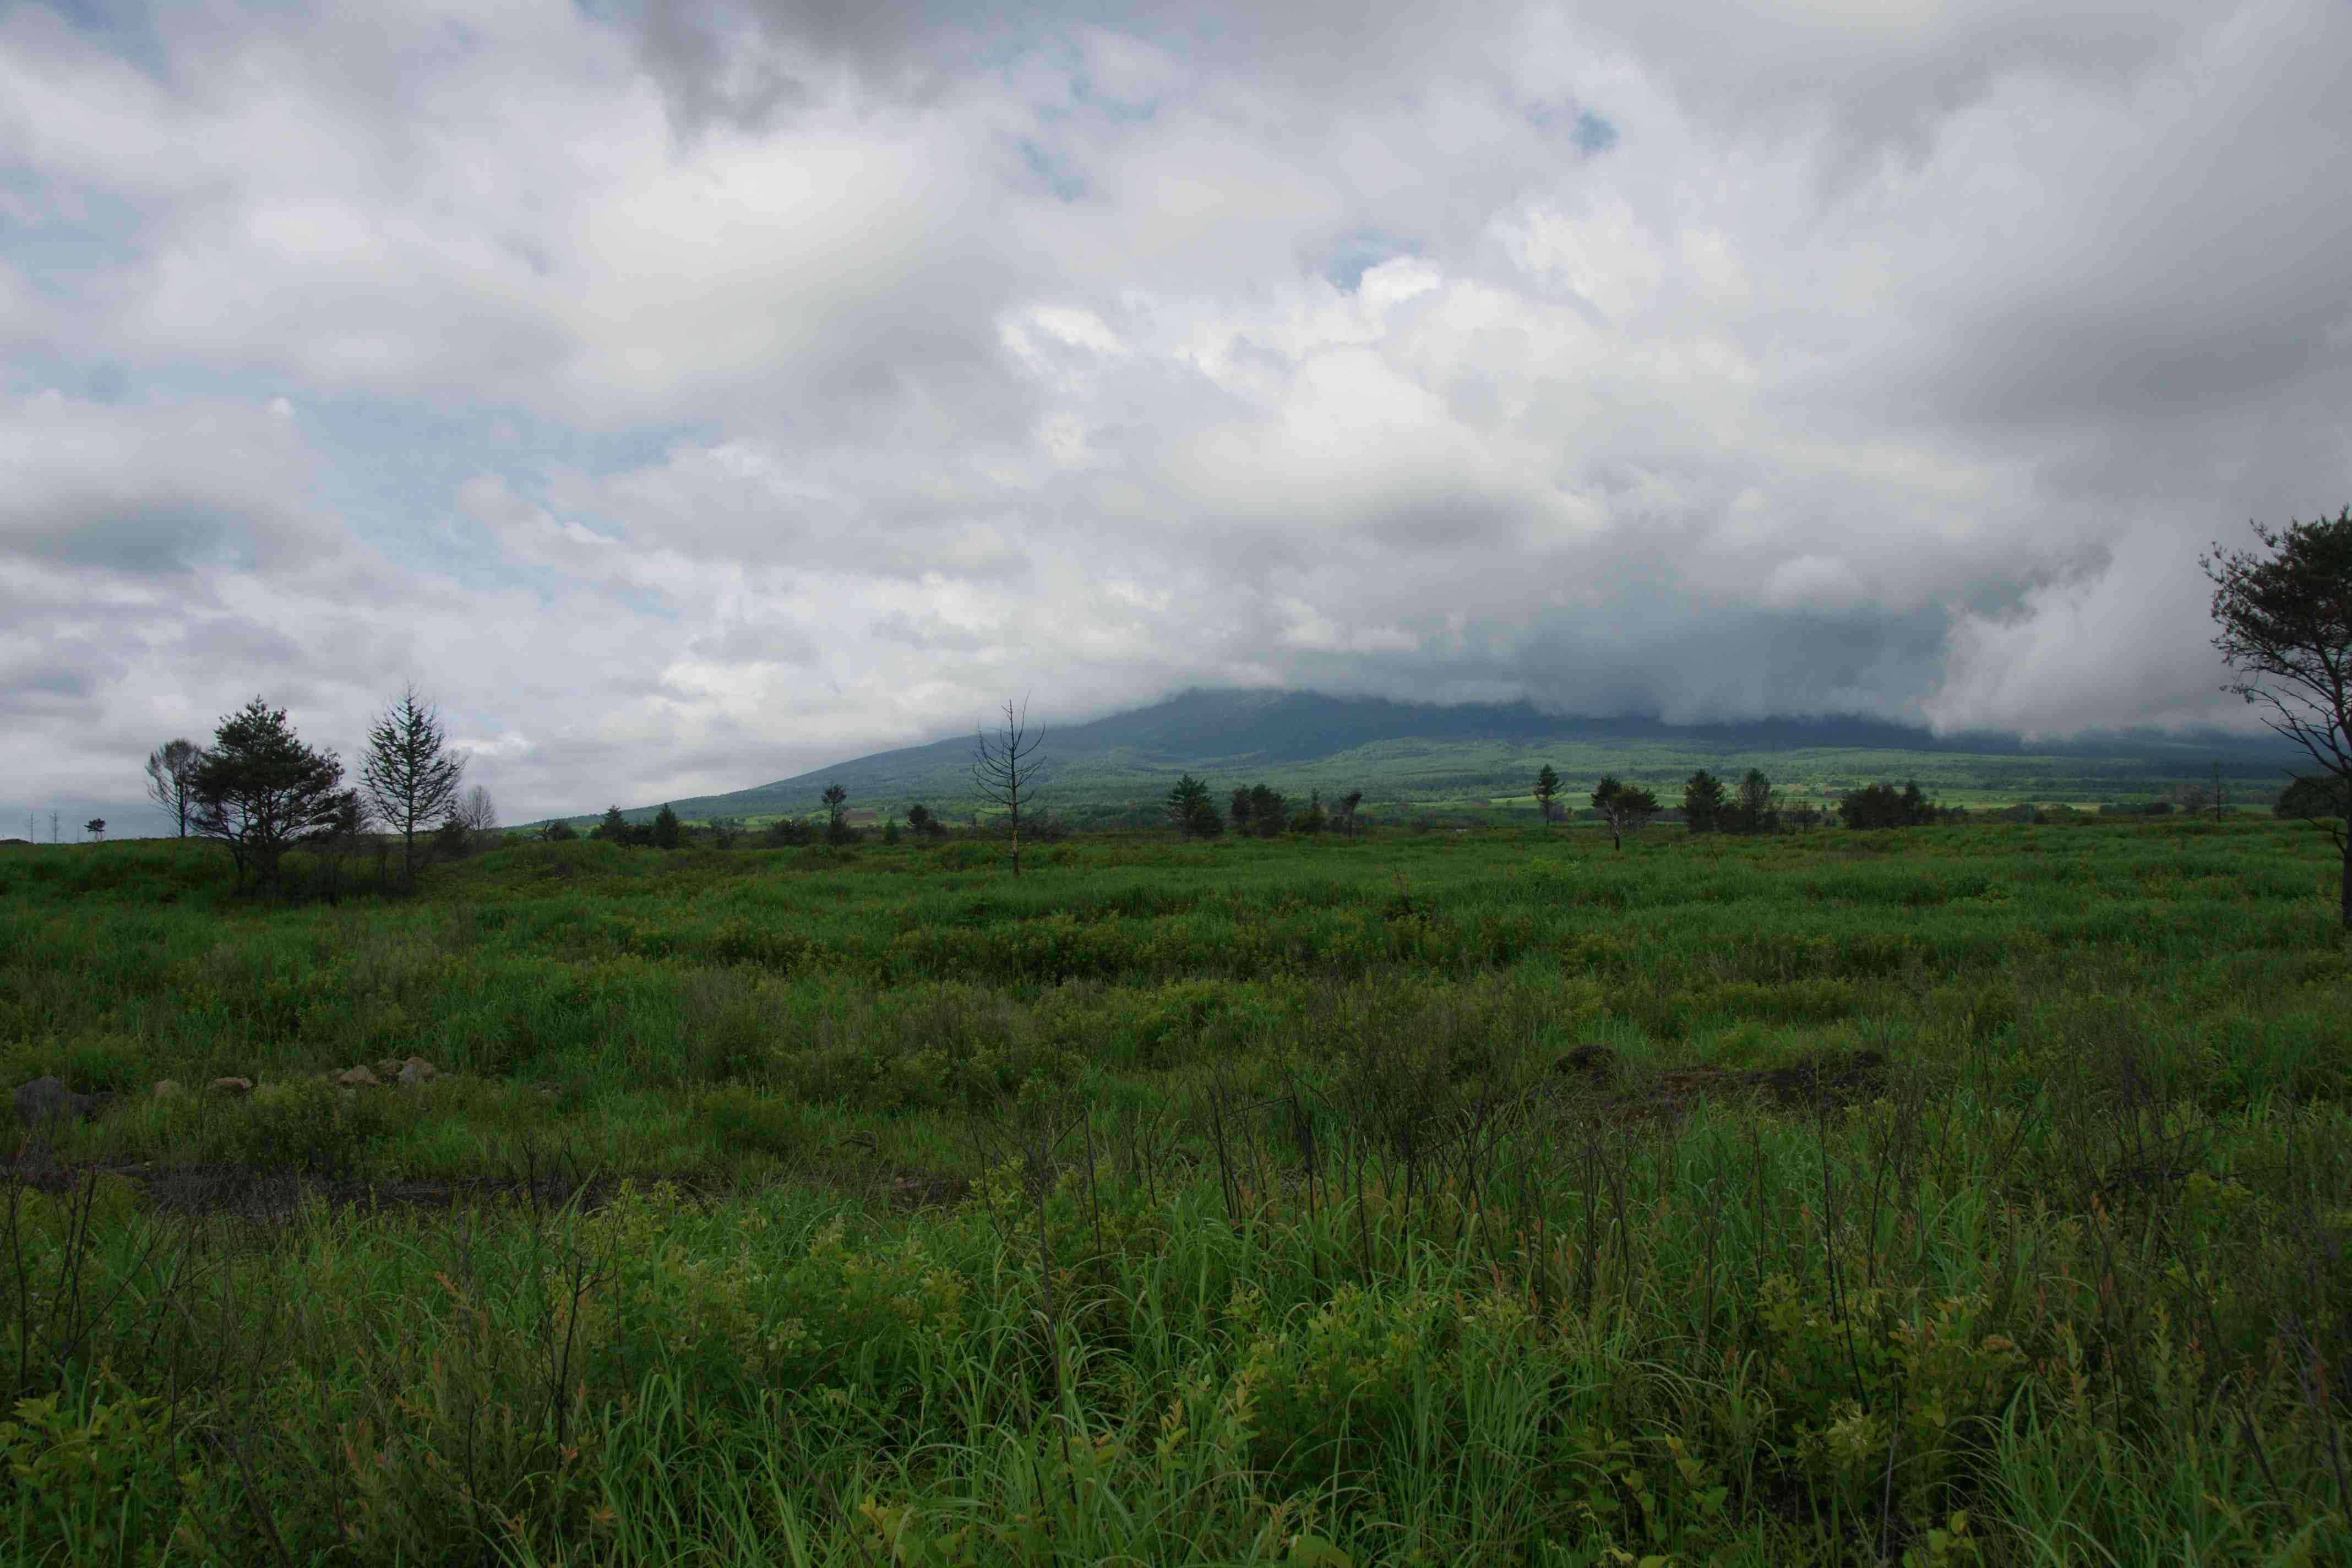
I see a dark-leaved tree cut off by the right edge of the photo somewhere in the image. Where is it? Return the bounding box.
[2199,508,2352,931]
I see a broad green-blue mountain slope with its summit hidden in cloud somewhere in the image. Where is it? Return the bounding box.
[546,691,2291,823]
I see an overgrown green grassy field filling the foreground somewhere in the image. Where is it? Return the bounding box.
[0,818,2352,1568]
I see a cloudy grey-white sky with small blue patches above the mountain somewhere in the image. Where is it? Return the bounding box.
[0,0,2352,837]
